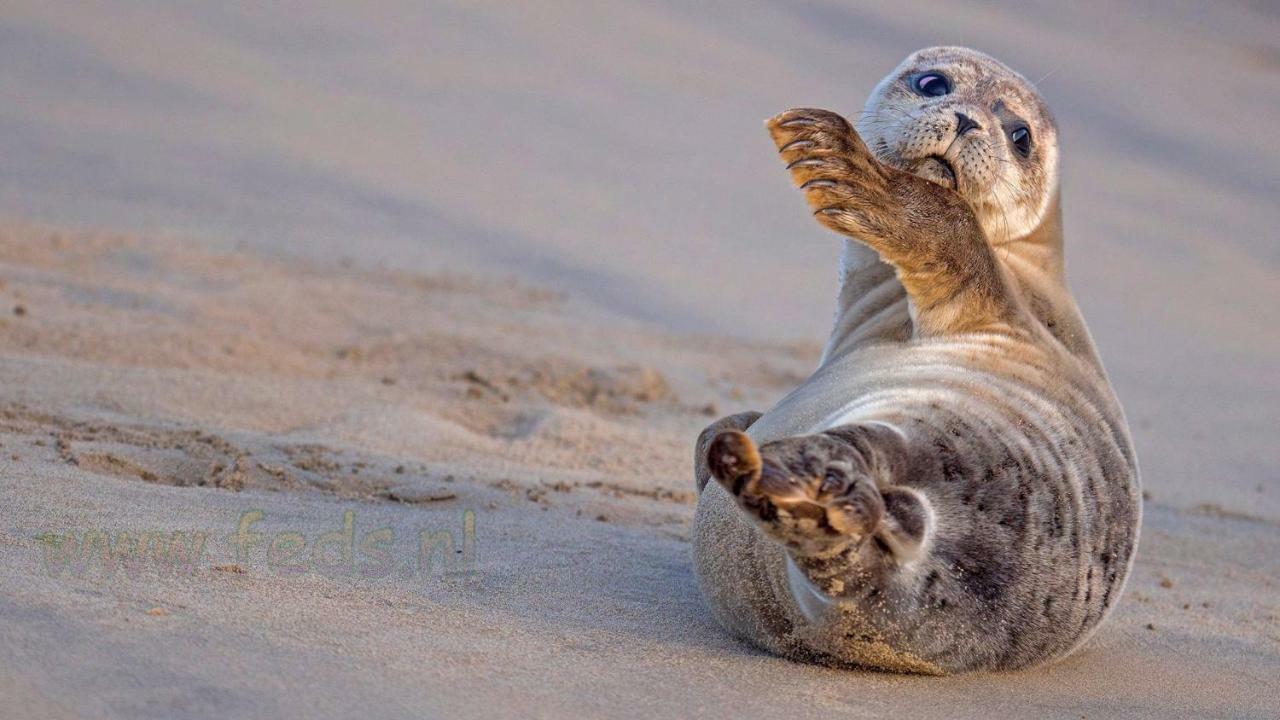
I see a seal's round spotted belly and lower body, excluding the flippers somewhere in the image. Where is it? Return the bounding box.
[694,336,1138,673]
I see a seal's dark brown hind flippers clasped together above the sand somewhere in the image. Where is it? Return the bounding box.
[705,424,932,564]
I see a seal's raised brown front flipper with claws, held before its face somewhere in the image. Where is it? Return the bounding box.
[767,109,1019,336]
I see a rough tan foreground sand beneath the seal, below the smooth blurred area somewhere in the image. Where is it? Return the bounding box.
[0,225,1280,717]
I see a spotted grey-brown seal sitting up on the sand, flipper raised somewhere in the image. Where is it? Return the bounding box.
[694,47,1142,674]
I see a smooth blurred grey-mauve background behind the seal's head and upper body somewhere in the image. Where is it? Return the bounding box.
[0,0,1280,520]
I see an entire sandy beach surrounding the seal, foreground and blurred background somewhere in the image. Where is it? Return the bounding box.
[0,0,1280,717]
